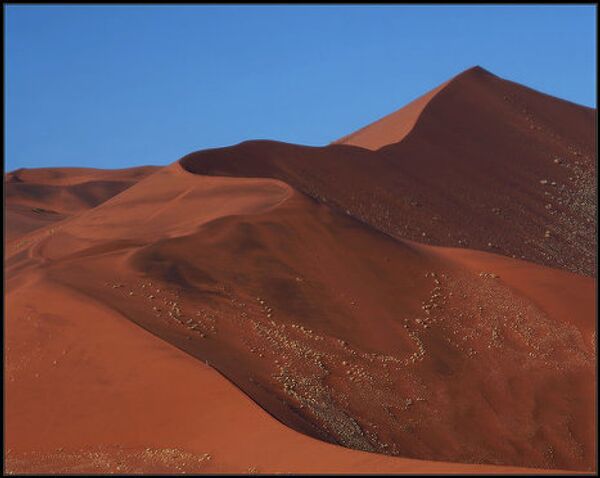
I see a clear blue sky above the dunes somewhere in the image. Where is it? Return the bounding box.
[4,5,596,171]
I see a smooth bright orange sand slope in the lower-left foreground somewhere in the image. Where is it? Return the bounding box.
[5,282,576,474]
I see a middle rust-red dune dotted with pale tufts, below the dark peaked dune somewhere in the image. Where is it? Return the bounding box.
[6,157,596,470]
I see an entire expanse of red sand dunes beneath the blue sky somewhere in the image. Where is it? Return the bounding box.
[5,68,597,474]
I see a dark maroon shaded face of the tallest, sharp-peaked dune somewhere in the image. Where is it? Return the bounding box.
[181,68,597,275]
